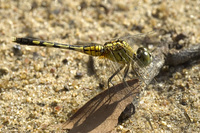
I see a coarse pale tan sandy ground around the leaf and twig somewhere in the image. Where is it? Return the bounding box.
[0,0,200,132]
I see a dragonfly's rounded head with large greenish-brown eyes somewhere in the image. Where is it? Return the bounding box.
[136,47,152,67]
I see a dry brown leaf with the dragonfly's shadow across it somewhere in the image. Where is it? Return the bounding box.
[50,79,141,133]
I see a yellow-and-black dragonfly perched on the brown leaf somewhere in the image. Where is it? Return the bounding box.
[13,37,152,88]
